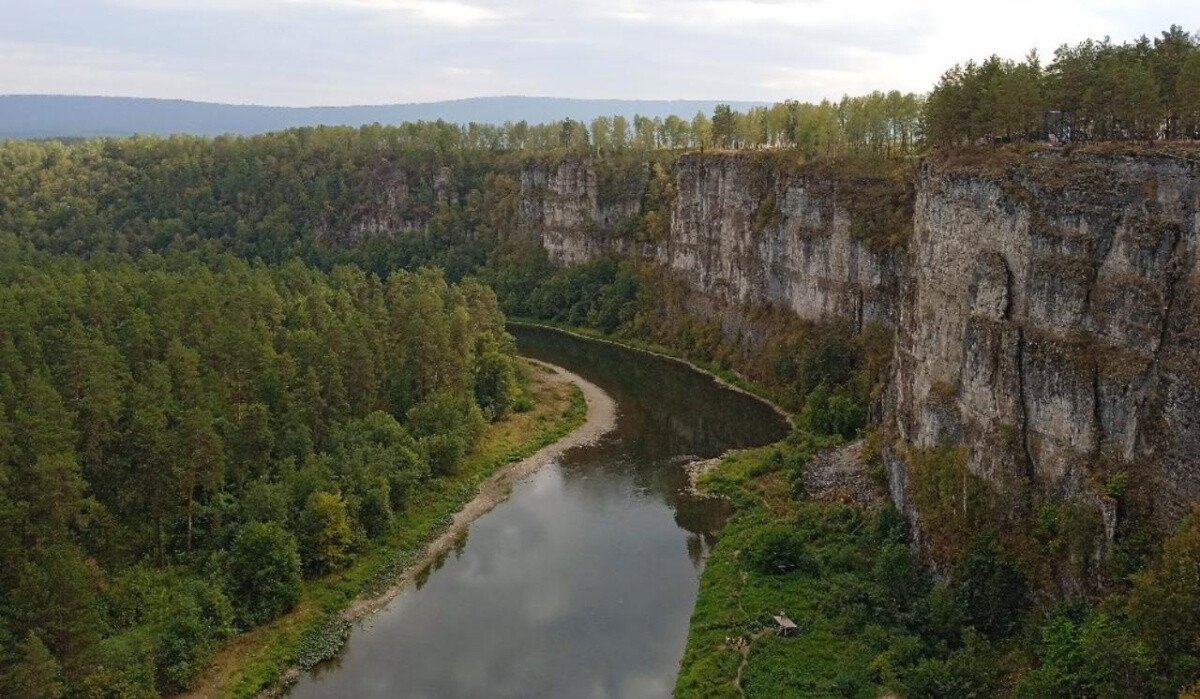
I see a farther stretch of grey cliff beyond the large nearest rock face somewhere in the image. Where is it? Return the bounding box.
[521,154,902,328]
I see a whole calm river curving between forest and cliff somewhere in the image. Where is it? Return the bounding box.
[289,328,786,699]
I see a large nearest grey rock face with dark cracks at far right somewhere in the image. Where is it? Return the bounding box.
[888,151,1200,536]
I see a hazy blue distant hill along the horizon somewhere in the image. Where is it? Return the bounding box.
[0,95,760,138]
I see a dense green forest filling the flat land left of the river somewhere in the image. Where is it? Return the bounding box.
[0,235,525,697]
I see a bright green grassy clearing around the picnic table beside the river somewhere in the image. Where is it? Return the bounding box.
[676,446,902,698]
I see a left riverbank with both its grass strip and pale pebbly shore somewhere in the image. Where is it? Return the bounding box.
[175,362,616,699]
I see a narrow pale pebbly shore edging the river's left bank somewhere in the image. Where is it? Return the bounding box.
[259,358,617,697]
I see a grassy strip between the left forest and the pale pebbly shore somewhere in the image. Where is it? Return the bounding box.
[181,365,587,697]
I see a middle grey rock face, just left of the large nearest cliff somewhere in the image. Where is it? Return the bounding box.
[647,155,900,329]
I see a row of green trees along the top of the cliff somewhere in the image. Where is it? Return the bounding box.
[578,25,1200,151]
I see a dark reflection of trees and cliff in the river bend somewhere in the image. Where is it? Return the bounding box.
[512,328,786,542]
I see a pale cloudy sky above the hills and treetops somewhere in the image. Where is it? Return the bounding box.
[0,0,1200,106]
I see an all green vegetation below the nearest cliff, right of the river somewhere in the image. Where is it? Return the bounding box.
[676,431,1200,699]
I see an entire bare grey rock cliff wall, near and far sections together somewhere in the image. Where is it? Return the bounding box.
[511,150,1200,536]
